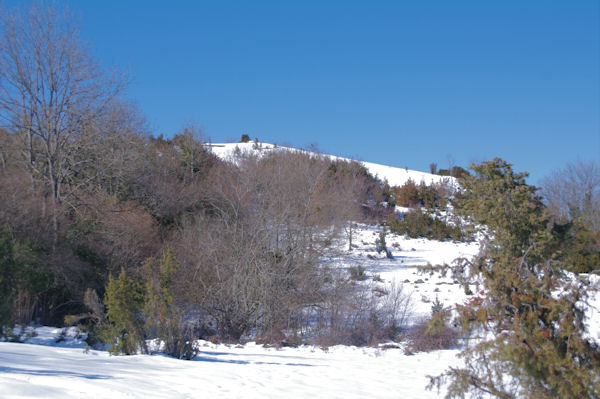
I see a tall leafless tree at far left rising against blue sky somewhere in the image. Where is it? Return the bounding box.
[0,3,124,246]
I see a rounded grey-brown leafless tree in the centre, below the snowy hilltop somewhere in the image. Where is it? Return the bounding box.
[172,152,366,339]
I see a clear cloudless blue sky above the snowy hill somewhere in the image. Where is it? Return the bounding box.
[17,0,600,183]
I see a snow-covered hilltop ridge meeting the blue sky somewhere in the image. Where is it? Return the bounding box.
[206,142,456,186]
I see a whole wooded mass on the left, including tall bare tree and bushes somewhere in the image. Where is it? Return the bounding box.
[0,4,410,358]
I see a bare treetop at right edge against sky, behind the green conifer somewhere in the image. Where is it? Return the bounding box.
[542,161,600,232]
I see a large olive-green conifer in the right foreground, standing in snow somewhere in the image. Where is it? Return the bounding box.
[430,159,600,398]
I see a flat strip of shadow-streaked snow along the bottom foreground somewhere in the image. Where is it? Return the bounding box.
[0,334,456,398]
